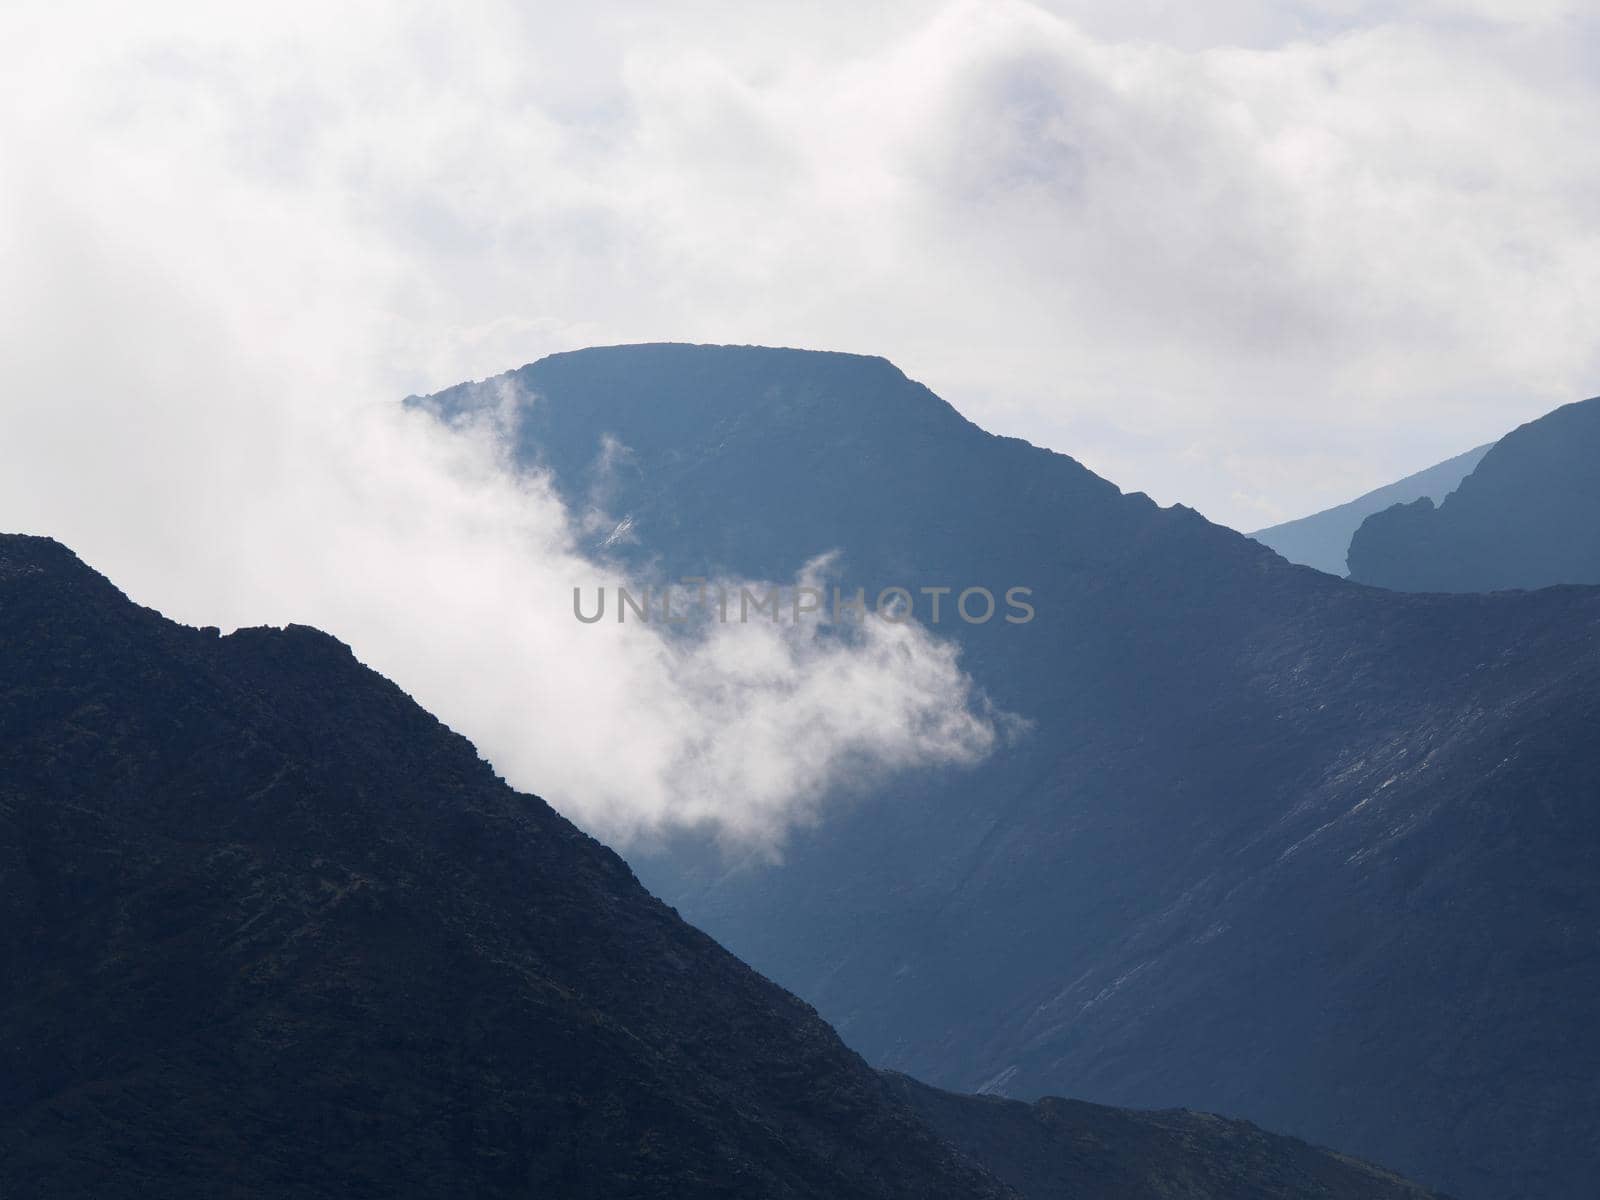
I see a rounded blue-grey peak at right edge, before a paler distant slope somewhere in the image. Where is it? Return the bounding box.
[1350,397,1600,592]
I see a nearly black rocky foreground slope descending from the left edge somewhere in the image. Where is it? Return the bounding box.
[0,536,1003,1198]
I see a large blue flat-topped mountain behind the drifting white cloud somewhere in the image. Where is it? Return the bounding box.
[411,346,1600,1200]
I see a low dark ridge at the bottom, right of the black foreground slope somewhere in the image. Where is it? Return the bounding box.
[888,1072,1434,1200]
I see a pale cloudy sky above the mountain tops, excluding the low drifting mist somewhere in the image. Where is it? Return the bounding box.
[12,0,1600,528]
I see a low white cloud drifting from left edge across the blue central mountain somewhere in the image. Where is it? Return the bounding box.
[0,232,995,854]
